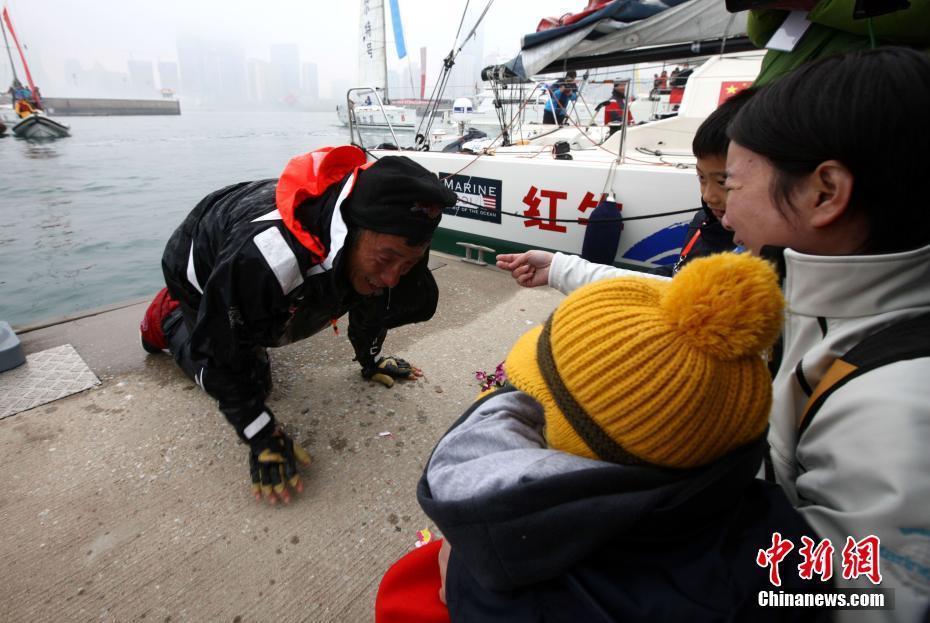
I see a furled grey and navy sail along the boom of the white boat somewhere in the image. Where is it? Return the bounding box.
[504,0,746,78]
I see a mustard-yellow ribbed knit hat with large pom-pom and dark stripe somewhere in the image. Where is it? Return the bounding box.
[505,253,784,468]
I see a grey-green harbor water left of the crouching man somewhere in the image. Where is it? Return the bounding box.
[0,112,362,327]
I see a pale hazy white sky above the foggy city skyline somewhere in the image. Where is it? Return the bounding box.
[0,0,586,95]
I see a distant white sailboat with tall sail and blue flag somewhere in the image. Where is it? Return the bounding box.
[336,0,417,129]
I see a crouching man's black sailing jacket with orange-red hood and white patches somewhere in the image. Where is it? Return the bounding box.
[162,146,439,439]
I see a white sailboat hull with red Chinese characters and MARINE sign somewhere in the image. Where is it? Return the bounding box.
[373,150,699,268]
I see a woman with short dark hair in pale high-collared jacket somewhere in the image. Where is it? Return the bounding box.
[723,48,930,621]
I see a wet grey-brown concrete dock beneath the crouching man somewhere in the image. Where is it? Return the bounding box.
[0,253,562,623]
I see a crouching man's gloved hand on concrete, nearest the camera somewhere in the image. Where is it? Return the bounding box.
[249,429,312,504]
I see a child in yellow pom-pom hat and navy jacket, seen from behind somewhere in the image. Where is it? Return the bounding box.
[417,254,825,622]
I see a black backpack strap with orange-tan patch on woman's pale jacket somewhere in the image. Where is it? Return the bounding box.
[798,314,930,438]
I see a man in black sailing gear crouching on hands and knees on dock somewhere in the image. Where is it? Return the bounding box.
[140,146,456,503]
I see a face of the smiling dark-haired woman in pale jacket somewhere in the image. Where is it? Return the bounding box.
[721,141,809,255]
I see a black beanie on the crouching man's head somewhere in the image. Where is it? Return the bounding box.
[342,156,458,245]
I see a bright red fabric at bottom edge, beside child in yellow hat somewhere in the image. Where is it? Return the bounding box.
[375,539,449,623]
